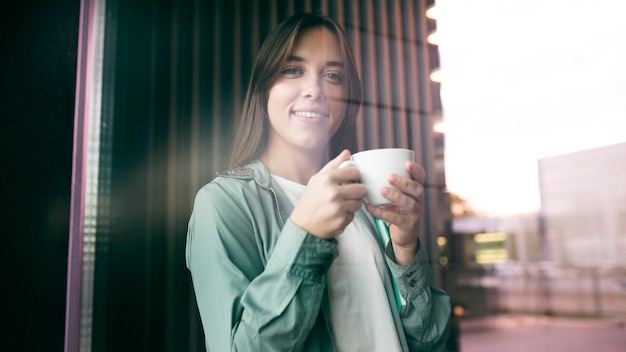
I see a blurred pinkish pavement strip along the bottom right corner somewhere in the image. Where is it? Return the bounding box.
[460,315,626,352]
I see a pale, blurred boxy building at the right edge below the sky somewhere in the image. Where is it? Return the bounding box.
[539,143,626,267]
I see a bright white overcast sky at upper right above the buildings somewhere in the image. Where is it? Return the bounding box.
[436,0,626,216]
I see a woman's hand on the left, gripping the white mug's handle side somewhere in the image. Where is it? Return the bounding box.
[290,150,367,239]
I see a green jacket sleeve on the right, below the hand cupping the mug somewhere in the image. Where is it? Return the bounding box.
[386,245,451,351]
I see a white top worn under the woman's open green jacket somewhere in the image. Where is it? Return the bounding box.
[272,175,402,352]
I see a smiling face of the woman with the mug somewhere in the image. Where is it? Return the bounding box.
[267,27,346,157]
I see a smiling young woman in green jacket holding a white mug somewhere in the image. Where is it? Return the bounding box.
[186,14,450,351]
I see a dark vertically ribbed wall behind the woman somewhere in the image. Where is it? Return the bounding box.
[72,0,448,351]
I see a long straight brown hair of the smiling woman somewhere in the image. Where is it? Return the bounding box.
[230,13,361,167]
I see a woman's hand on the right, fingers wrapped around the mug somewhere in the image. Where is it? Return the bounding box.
[367,161,426,265]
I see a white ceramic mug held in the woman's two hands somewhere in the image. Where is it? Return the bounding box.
[339,148,415,205]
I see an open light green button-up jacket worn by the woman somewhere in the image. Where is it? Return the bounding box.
[186,160,450,352]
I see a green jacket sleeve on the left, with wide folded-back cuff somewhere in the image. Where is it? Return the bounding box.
[186,183,337,351]
